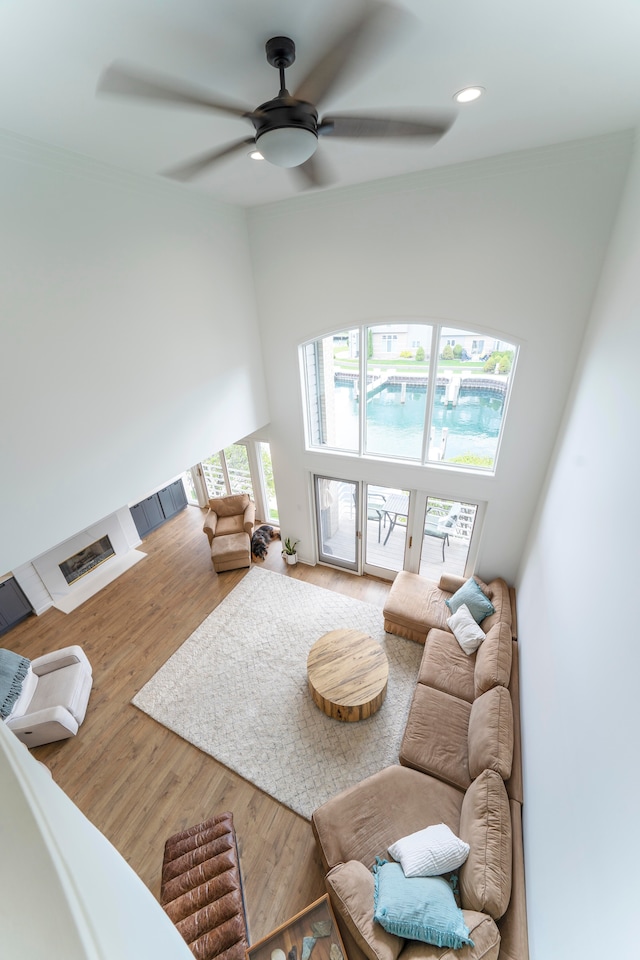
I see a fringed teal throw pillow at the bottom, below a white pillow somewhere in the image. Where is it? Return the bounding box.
[373,858,474,950]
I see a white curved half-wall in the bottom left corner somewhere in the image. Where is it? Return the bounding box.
[0,723,193,960]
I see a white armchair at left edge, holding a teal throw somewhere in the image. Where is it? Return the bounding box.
[5,646,93,747]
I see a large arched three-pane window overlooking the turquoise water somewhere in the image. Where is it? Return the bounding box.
[301,323,517,470]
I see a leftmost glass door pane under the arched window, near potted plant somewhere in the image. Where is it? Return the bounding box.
[315,477,358,570]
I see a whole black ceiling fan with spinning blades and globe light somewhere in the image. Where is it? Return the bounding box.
[98,2,453,187]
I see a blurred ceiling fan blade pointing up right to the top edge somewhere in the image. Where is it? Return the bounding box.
[293,0,404,107]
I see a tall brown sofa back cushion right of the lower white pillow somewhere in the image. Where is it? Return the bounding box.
[458,770,511,920]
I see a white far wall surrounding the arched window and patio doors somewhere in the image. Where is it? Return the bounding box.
[249,135,630,579]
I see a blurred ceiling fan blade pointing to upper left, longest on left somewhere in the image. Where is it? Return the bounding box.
[98,62,257,119]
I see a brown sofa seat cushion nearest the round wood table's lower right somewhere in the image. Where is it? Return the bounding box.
[402,683,471,792]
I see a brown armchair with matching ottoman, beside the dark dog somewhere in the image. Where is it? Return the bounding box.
[202,493,256,573]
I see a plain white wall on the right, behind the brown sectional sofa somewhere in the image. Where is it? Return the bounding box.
[518,131,640,960]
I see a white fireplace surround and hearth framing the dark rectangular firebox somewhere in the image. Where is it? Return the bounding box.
[13,507,146,613]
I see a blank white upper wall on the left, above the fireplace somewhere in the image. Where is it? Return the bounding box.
[0,136,269,572]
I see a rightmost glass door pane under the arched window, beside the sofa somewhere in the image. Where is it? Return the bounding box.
[420,497,478,580]
